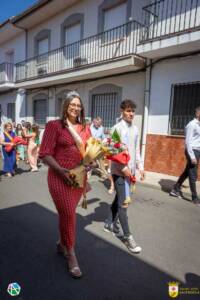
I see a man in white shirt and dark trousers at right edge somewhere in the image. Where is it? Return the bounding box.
[170,107,200,206]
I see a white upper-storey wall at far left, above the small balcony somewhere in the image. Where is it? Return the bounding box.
[0,33,26,63]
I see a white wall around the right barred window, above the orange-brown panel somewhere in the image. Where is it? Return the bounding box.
[148,56,200,134]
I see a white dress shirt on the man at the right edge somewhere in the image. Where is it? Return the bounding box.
[185,119,200,160]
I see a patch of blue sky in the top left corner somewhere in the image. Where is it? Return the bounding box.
[0,0,38,24]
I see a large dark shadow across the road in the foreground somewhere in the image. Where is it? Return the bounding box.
[0,199,192,300]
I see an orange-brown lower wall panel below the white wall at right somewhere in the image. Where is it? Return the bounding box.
[145,134,200,179]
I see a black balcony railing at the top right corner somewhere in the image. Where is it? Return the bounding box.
[140,0,200,42]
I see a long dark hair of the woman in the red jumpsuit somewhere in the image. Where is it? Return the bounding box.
[61,91,86,127]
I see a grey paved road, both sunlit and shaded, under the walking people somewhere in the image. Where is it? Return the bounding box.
[0,166,200,300]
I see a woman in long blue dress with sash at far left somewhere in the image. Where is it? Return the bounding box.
[0,123,16,177]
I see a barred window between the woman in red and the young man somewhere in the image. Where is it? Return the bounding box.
[91,92,119,129]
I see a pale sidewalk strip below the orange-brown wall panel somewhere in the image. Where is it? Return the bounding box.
[138,171,200,196]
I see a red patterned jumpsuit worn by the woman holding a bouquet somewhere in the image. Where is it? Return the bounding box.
[39,120,91,250]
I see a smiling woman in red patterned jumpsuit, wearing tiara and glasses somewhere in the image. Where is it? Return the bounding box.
[40,92,90,278]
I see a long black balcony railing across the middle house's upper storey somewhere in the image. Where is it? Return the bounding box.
[16,21,141,82]
